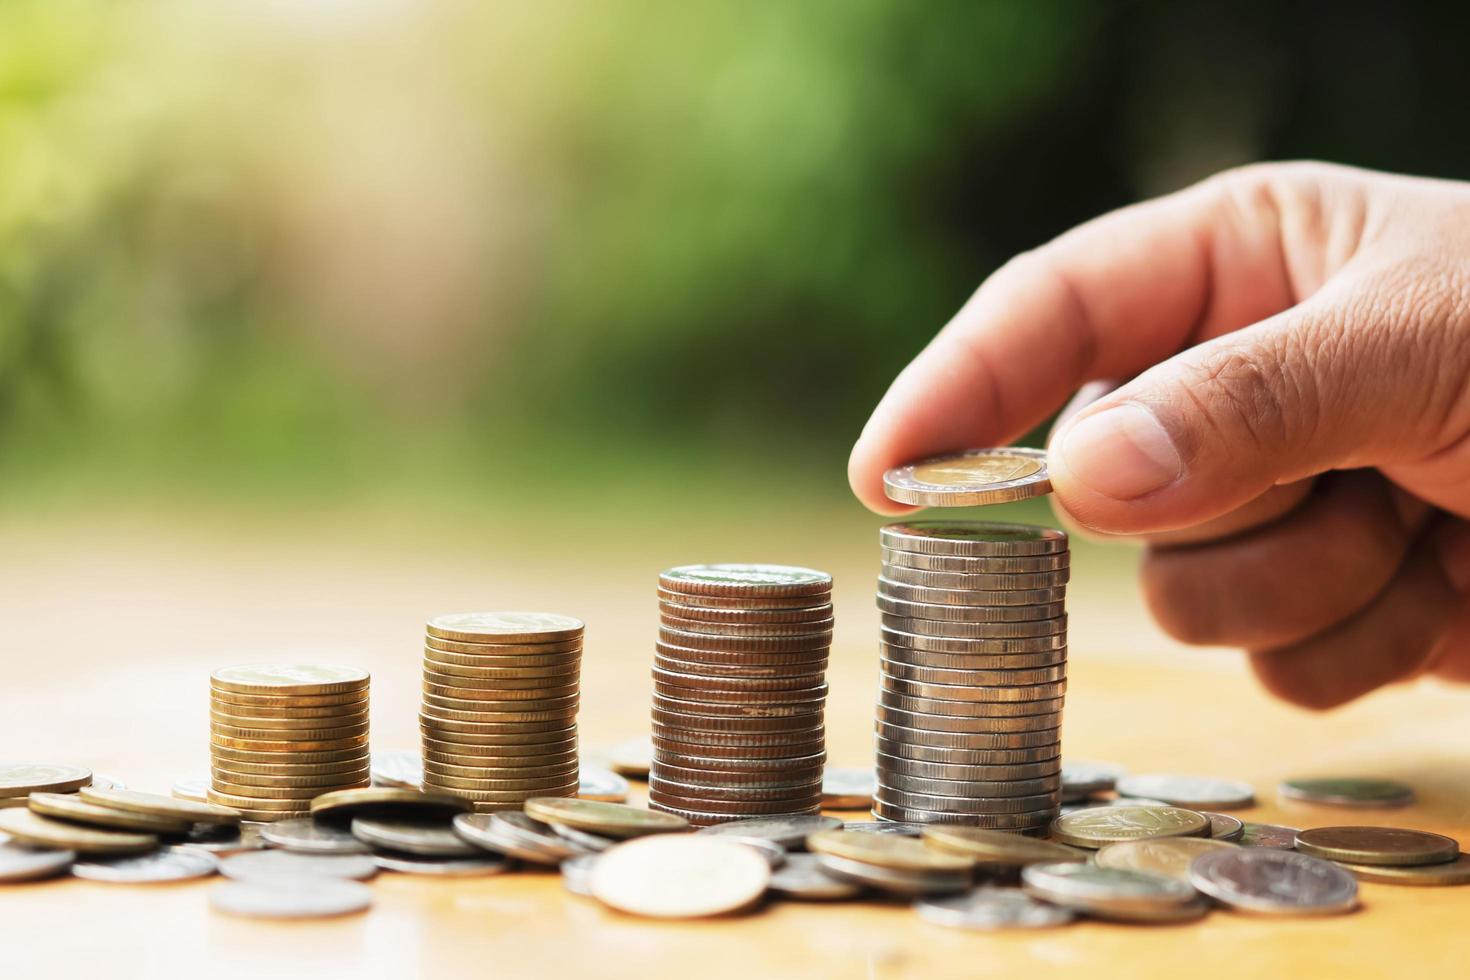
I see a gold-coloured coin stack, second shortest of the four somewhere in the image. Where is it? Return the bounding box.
[419,613,584,811]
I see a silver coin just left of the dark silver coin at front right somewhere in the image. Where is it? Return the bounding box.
[1020,862,1198,921]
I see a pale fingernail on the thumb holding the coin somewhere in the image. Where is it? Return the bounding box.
[1060,404,1185,500]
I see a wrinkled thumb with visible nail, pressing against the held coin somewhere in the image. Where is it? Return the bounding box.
[1050,274,1467,533]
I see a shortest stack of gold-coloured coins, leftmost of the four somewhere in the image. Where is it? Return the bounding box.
[207,664,369,820]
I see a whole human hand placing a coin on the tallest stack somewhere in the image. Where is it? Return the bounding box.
[848,163,1470,708]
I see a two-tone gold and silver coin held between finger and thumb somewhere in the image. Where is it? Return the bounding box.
[883,447,1051,507]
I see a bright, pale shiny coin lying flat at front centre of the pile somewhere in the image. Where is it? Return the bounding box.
[591,835,770,918]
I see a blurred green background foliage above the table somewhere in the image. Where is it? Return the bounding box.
[0,0,1470,511]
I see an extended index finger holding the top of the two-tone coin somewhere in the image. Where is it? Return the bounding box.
[848,179,1292,514]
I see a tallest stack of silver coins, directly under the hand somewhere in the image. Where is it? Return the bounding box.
[873,522,1070,832]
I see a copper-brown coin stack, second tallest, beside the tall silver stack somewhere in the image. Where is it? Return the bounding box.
[648,564,832,826]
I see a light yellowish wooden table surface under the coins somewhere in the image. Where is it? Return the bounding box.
[0,522,1470,980]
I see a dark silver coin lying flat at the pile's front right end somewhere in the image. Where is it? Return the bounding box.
[1189,848,1358,915]
